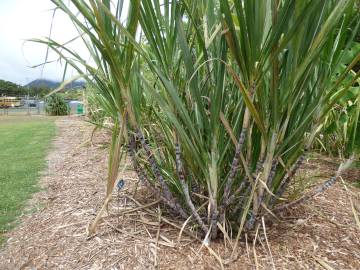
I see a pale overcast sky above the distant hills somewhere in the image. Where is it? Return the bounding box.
[0,0,82,85]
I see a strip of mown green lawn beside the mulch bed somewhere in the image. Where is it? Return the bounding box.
[0,116,55,244]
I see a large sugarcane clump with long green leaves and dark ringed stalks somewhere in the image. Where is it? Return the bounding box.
[37,0,360,243]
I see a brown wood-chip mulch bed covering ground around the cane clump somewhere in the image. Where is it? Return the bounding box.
[0,117,360,270]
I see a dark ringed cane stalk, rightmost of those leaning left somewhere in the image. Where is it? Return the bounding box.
[175,142,209,234]
